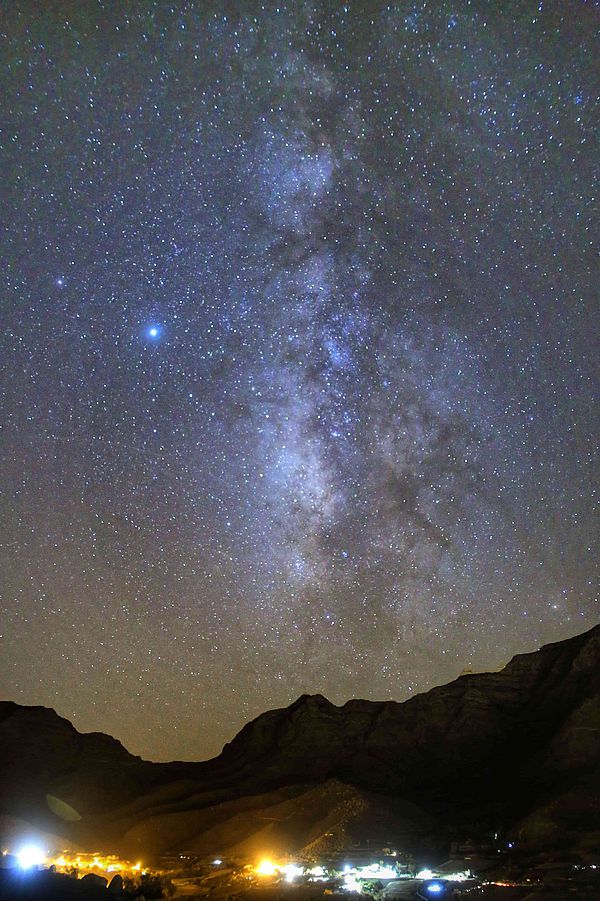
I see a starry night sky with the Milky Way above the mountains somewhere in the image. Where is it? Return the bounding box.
[0,0,600,760]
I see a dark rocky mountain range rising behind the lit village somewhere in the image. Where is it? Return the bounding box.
[0,627,600,855]
